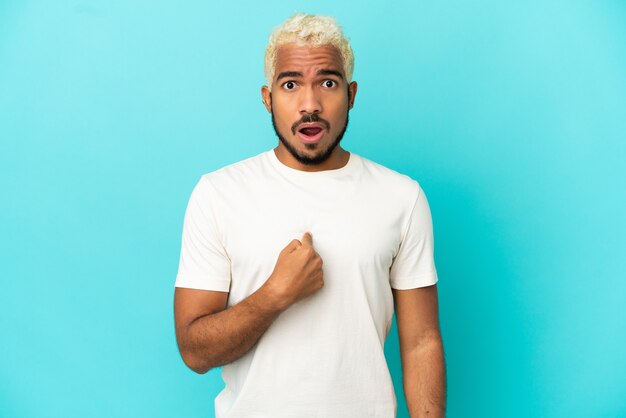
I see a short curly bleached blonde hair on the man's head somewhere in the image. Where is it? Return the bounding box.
[265,12,354,91]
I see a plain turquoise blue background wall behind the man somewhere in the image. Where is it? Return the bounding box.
[0,0,626,417]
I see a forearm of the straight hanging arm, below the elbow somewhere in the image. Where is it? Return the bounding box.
[402,335,446,418]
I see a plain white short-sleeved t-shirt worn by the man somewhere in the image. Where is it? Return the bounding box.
[175,149,437,418]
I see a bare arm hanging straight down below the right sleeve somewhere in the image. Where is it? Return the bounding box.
[392,284,446,418]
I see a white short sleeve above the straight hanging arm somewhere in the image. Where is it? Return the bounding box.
[389,185,438,289]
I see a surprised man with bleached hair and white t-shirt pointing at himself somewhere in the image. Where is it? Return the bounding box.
[174,14,445,418]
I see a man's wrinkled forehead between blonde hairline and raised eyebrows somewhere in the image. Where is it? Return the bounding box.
[276,43,343,74]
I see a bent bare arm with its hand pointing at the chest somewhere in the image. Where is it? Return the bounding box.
[174,232,324,374]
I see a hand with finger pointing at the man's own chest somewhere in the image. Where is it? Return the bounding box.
[265,232,324,309]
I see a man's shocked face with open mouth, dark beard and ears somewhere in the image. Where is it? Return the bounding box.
[262,44,356,165]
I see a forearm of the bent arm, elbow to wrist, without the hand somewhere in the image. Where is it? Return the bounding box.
[180,286,285,373]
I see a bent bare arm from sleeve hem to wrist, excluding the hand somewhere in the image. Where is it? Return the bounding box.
[174,282,284,374]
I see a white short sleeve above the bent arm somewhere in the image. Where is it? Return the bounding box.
[175,176,230,292]
